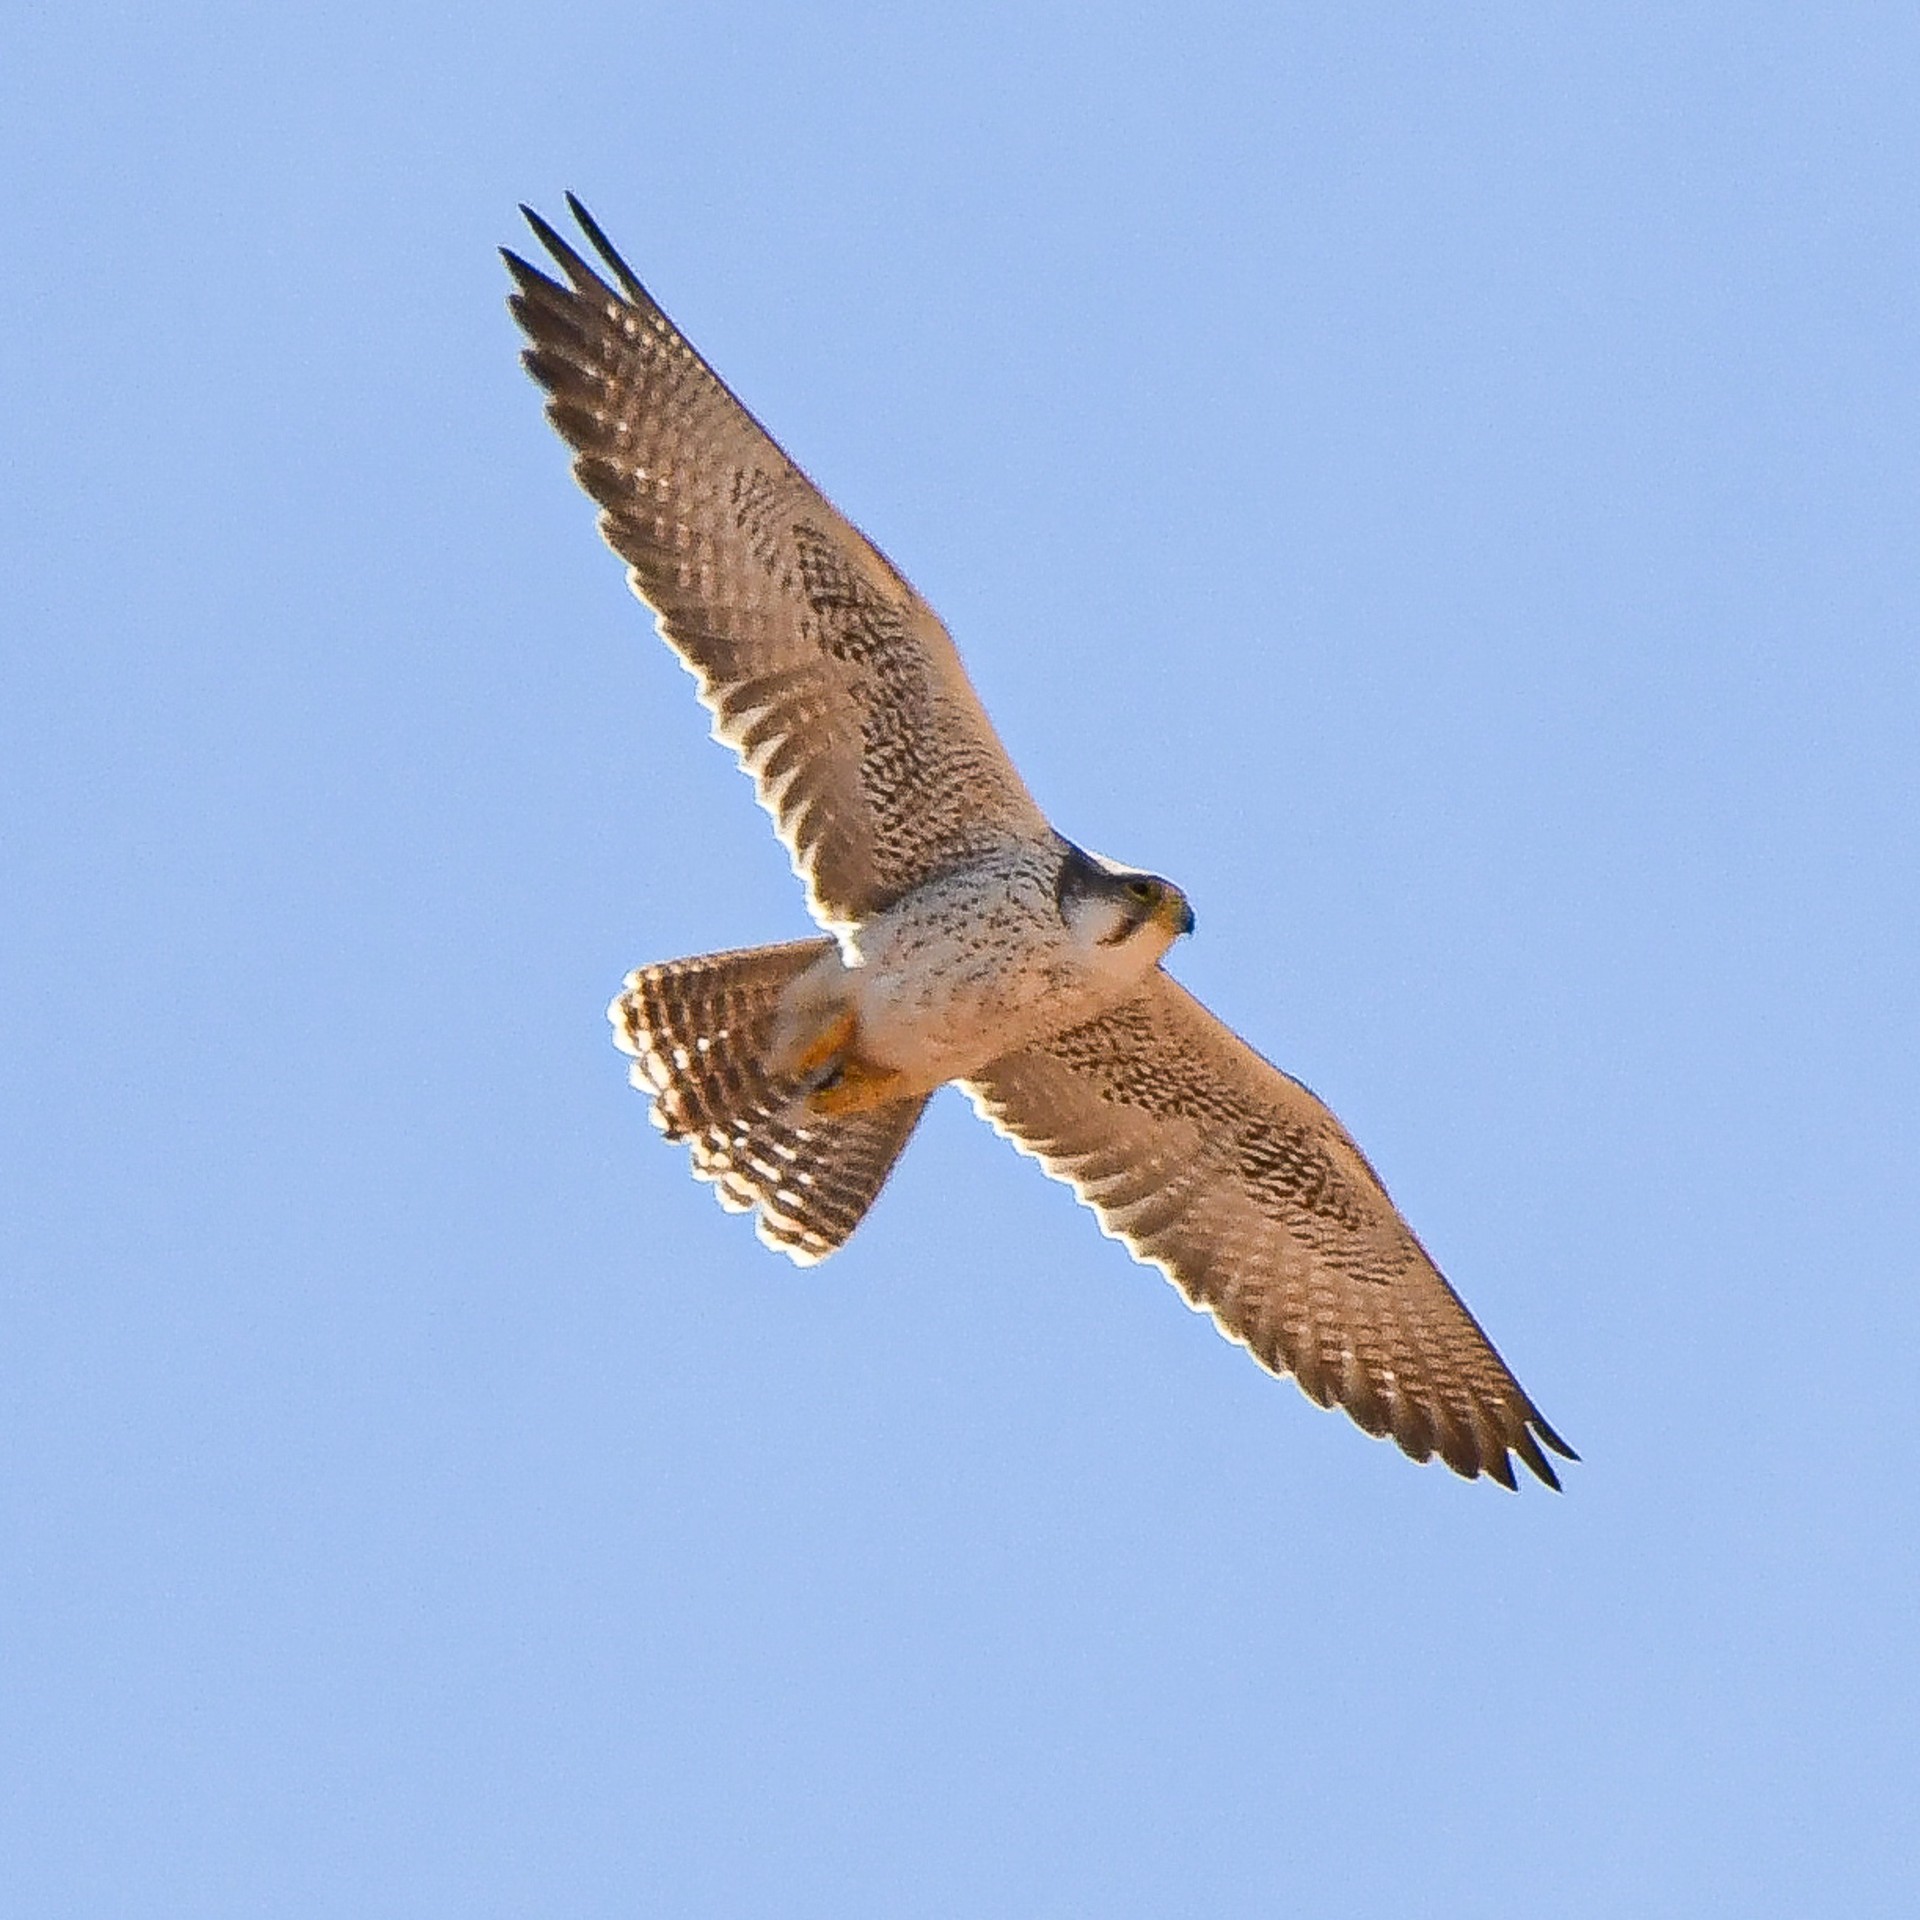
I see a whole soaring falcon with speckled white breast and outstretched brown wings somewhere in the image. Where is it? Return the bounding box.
[505,196,1576,1488]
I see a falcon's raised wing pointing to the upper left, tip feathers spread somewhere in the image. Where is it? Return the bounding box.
[505,196,1046,927]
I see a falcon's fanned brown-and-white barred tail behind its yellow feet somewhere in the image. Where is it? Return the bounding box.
[607,939,927,1265]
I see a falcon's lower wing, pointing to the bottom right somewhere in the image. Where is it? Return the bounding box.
[968,970,1574,1488]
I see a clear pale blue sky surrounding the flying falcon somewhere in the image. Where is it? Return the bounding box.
[0,0,1920,1920]
